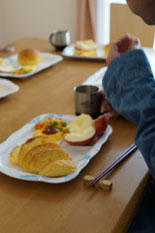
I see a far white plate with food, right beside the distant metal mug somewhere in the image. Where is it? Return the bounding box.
[62,45,106,61]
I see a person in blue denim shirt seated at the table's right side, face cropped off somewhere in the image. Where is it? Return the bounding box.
[103,0,155,233]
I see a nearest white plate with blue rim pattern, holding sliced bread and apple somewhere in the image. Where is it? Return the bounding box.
[0,114,112,183]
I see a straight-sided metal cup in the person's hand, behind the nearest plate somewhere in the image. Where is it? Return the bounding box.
[74,85,102,118]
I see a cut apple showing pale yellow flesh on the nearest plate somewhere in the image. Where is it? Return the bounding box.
[64,114,96,146]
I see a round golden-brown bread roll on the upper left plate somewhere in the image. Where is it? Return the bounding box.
[18,49,41,65]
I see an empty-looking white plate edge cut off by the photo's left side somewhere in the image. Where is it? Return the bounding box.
[0,78,19,98]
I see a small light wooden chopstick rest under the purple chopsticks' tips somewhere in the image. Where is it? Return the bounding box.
[83,175,112,191]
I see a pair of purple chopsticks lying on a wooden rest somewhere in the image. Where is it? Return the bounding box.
[88,144,137,187]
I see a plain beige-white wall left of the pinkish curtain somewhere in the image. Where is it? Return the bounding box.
[0,0,77,46]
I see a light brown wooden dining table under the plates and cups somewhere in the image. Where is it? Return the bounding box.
[0,38,149,233]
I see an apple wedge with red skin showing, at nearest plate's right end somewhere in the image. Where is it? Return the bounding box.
[94,114,109,136]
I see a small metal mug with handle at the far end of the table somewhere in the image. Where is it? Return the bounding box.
[49,31,70,51]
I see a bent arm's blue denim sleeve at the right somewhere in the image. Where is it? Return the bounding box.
[103,50,155,178]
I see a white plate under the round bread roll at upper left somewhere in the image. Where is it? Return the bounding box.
[0,53,63,79]
